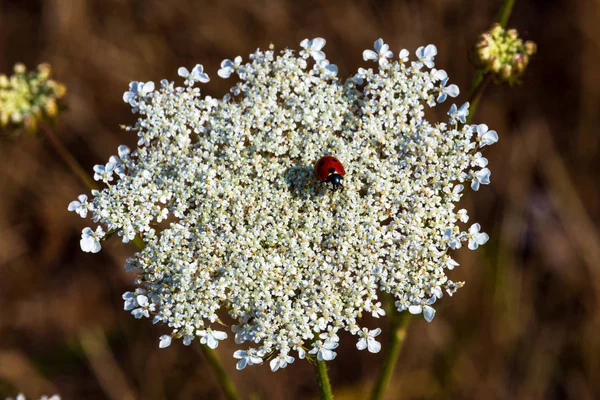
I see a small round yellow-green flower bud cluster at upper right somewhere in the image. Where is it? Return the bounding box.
[472,24,537,85]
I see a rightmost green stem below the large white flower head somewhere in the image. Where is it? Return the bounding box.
[371,311,410,400]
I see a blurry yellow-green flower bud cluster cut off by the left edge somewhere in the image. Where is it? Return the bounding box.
[0,63,66,135]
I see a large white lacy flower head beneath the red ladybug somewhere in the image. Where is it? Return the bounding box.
[69,38,498,370]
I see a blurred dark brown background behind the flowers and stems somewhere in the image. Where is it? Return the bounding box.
[0,0,600,399]
